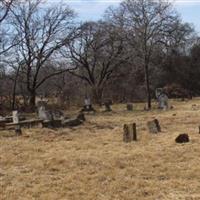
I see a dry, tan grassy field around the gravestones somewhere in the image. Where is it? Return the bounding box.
[0,99,200,200]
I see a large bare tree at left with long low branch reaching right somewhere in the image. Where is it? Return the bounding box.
[12,0,74,107]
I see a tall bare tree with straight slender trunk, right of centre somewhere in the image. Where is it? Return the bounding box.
[107,0,187,109]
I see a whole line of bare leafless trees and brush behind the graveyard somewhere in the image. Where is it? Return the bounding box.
[0,0,200,109]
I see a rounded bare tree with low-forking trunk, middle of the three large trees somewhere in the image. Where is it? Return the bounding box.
[63,22,128,103]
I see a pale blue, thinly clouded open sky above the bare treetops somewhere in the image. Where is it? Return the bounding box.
[49,0,200,32]
